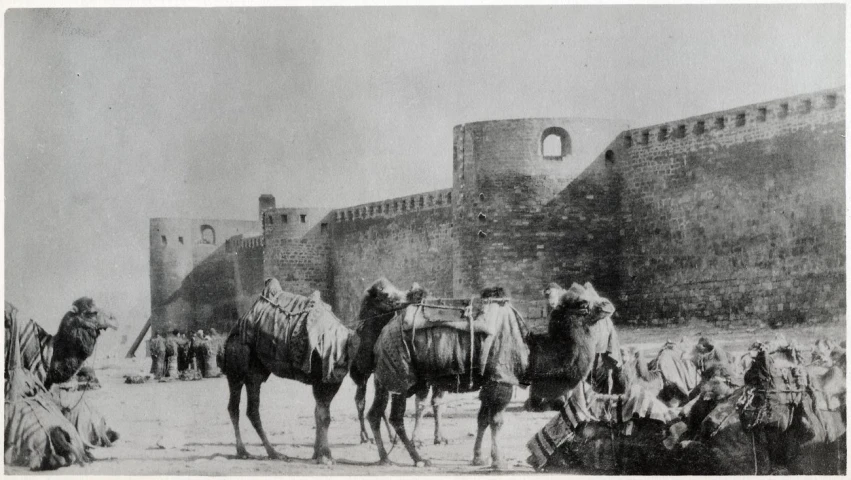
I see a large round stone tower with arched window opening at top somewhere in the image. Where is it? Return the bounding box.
[452,118,627,299]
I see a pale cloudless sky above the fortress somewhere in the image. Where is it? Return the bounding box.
[4,4,845,350]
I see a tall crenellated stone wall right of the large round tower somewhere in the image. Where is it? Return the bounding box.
[618,89,845,324]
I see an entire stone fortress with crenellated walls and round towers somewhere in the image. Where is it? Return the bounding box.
[150,88,845,332]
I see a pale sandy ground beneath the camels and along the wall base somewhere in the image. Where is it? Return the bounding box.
[5,325,846,476]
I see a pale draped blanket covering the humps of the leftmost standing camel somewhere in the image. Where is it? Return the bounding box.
[234,279,356,383]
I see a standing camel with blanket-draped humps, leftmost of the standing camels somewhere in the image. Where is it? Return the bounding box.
[223,278,358,464]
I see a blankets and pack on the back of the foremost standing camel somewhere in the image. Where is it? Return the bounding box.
[374,301,529,393]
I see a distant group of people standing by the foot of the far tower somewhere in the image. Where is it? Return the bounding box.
[149,329,224,379]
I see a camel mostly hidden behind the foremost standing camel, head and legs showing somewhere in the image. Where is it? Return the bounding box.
[349,278,446,444]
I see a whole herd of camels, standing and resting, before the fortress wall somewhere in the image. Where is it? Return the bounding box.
[5,279,845,474]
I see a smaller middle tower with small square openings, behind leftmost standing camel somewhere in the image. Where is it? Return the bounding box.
[261,208,333,303]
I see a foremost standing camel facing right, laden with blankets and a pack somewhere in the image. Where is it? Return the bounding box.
[369,284,613,469]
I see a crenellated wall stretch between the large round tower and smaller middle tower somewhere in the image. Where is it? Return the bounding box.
[331,189,452,325]
